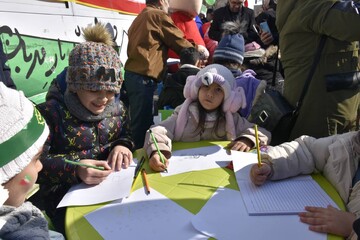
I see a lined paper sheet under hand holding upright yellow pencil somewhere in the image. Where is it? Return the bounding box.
[233,159,337,215]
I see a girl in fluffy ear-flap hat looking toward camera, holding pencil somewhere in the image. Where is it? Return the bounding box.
[144,64,271,171]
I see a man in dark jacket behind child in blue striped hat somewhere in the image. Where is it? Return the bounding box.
[209,0,259,44]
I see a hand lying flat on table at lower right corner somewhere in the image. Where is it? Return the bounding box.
[299,205,356,237]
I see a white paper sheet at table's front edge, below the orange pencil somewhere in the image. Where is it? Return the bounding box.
[85,189,207,240]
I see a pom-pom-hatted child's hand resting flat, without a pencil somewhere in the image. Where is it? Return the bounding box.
[107,145,133,171]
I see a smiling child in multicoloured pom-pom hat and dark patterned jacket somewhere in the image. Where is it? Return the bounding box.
[39,23,134,233]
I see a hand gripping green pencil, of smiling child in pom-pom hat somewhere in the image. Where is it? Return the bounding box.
[76,159,112,185]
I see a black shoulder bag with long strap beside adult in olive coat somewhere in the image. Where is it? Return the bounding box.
[248,36,326,145]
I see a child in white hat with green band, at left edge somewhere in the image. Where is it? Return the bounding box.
[0,83,64,240]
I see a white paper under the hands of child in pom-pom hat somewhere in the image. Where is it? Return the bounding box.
[57,164,135,208]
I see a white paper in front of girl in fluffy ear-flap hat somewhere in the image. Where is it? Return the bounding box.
[161,145,236,177]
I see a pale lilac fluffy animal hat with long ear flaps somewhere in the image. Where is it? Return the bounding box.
[175,64,246,140]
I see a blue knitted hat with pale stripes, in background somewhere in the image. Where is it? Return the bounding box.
[213,34,245,64]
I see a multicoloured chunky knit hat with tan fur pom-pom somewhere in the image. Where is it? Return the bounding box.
[66,23,122,93]
